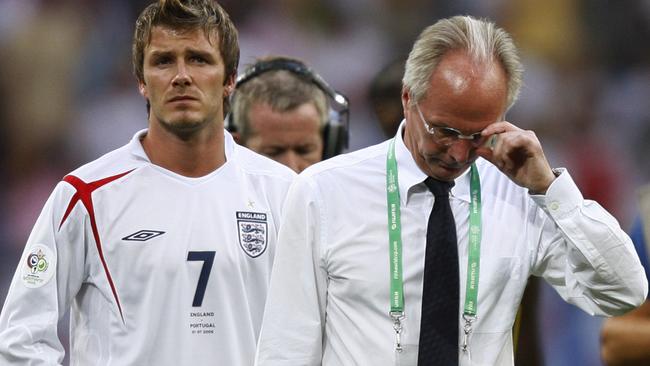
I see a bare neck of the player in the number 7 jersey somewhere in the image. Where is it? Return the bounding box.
[142,122,226,178]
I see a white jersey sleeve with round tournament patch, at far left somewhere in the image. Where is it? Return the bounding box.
[0,182,84,366]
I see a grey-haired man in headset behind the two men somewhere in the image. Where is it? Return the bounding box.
[228,56,347,173]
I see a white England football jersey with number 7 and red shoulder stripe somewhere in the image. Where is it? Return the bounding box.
[0,131,294,366]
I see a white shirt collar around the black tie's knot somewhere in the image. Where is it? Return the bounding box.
[395,120,470,205]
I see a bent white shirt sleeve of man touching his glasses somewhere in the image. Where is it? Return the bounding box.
[533,171,648,316]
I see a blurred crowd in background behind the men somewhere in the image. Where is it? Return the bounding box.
[0,0,650,366]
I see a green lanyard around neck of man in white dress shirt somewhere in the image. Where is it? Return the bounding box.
[386,139,481,352]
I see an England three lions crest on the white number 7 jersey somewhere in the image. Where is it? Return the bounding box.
[237,211,268,258]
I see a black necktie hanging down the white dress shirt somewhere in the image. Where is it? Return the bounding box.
[418,177,460,366]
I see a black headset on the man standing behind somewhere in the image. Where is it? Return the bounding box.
[225,58,350,159]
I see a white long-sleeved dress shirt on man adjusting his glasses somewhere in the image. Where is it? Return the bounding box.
[257,124,647,366]
